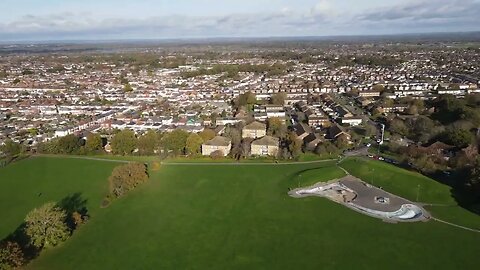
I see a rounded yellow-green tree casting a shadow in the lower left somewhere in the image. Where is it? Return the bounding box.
[25,202,70,248]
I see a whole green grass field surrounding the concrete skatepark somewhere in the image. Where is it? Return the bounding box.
[0,157,480,270]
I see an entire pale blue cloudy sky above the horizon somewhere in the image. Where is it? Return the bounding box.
[0,0,480,41]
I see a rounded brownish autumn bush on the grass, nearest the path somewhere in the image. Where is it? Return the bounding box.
[108,163,148,198]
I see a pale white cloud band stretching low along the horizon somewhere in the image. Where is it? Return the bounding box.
[0,0,480,40]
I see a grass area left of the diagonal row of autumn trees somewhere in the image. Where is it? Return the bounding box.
[0,157,118,239]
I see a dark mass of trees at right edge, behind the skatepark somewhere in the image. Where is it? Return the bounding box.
[383,94,480,202]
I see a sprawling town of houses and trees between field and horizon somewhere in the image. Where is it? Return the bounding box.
[0,41,480,191]
